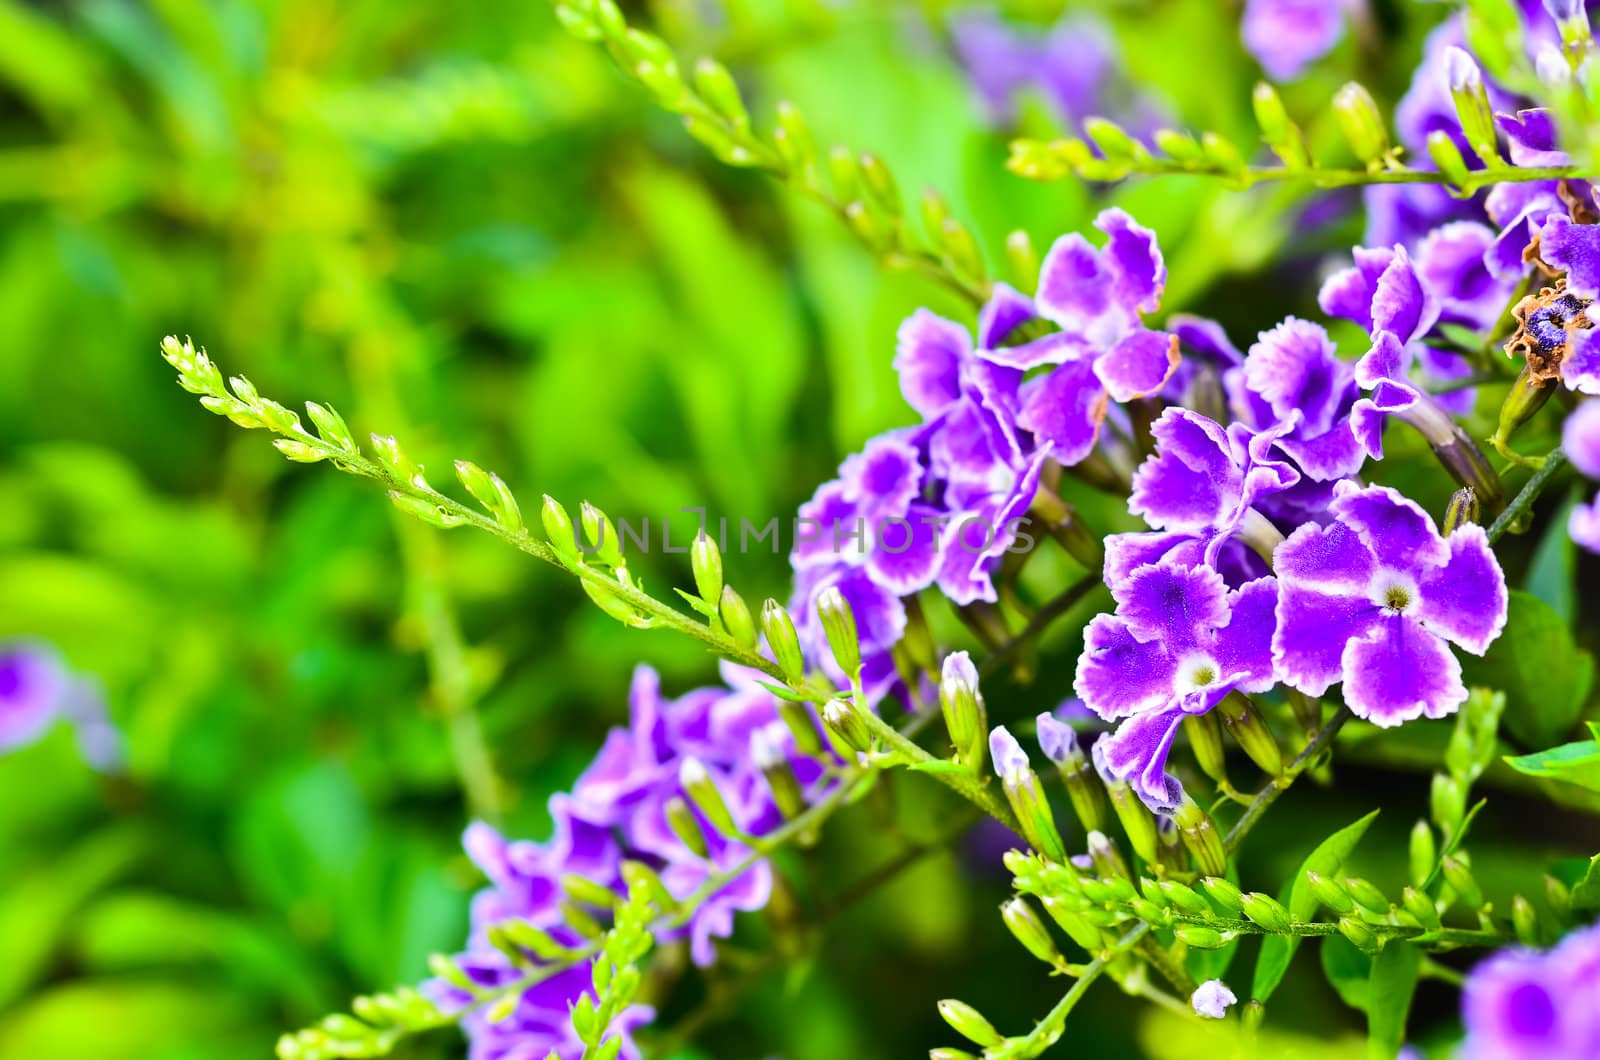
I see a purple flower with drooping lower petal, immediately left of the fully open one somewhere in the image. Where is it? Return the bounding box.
[1074,562,1277,809]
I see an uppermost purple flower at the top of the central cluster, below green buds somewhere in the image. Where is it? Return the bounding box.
[981,210,1179,464]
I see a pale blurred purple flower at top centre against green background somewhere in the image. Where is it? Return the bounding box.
[950,11,1165,136]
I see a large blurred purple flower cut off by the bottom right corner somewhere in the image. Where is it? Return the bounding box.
[1459,925,1600,1060]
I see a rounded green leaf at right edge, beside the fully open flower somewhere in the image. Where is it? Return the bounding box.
[1461,589,1594,748]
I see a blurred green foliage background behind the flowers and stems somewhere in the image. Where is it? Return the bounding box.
[0,0,1592,1060]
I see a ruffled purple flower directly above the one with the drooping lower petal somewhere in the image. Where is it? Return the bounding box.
[1106,408,1301,586]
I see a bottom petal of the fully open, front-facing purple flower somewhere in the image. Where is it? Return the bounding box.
[1342,615,1467,729]
